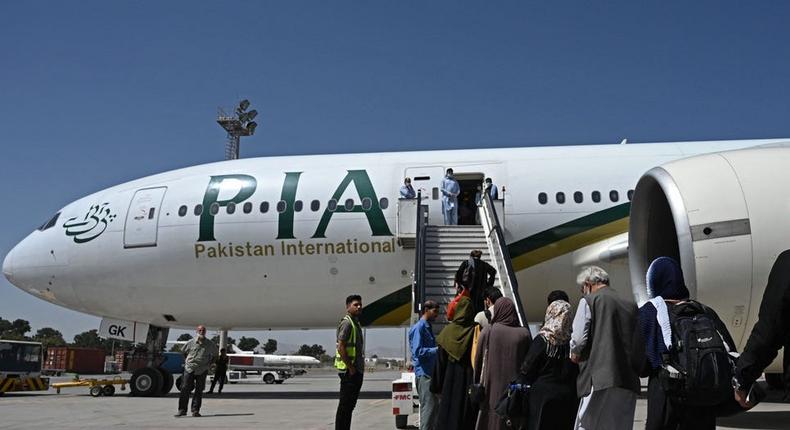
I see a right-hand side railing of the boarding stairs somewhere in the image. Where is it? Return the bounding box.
[481,190,527,327]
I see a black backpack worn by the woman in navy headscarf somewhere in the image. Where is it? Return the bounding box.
[659,301,734,406]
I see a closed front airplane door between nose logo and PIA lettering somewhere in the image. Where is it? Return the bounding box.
[123,187,167,248]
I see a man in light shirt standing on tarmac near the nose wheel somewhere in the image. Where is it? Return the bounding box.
[176,325,217,417]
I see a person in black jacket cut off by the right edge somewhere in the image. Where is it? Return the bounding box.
[735,250,790,408]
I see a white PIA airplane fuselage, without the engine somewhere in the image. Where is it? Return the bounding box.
[3,140,770,329]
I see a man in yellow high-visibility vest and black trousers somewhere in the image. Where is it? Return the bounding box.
[335,294,365,430]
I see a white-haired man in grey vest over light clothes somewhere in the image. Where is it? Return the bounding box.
[570,266,645,430]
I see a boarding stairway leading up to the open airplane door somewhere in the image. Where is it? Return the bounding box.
[398,193,527,333]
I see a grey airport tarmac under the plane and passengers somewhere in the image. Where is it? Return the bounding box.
[0,369,790,430]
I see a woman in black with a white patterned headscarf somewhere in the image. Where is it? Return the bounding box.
[519,300,579,430]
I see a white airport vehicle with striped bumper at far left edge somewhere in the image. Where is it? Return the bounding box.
[0,339,49,396]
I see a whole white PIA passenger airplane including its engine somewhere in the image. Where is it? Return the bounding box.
[3,139,790,394]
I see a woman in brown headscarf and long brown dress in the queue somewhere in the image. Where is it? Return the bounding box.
[475,297,531,430]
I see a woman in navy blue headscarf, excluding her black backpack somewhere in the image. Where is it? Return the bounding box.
[639,257,735,430]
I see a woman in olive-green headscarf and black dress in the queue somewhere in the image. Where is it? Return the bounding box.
[431,296,477,430]
